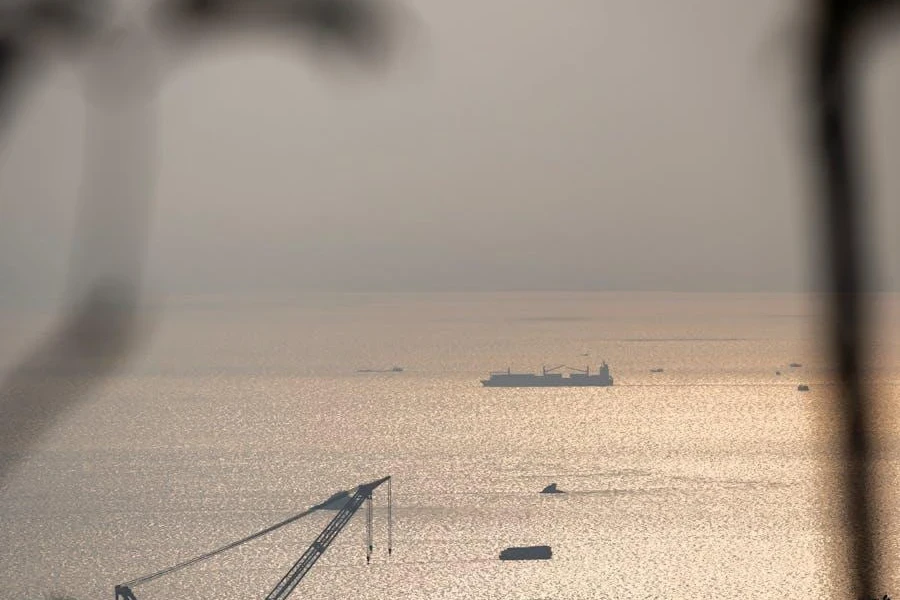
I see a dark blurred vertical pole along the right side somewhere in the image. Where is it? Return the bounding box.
[811,0,878,598]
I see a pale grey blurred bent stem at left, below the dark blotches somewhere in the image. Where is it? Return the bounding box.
[0,19,157,481]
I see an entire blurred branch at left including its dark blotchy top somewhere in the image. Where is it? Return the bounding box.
[0,0,400,482]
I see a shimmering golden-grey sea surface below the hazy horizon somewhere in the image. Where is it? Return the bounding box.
[0,293,900,600]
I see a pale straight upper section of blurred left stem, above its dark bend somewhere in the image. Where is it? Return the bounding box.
[67,27,158,303]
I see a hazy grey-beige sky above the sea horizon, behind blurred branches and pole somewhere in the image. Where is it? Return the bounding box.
[0,0,900,295]
